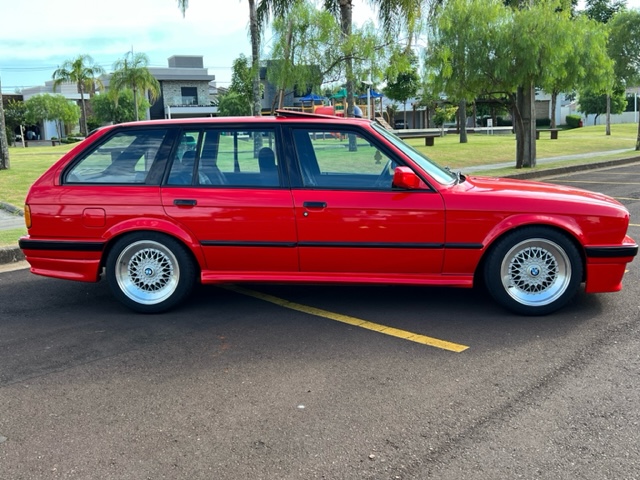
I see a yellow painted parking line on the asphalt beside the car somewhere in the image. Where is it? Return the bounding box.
[223,285,469,353]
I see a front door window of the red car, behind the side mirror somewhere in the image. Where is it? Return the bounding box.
[293,128,396,190]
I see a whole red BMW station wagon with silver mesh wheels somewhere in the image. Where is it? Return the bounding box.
[20,112,638,315]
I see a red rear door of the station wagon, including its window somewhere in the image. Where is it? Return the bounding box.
[162,126,298,279]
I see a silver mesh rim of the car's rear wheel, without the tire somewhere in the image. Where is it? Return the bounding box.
[114,240,180,305]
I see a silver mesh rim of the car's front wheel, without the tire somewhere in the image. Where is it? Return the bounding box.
[500,238,572,307]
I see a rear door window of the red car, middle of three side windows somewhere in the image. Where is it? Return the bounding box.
[167,129,281,187]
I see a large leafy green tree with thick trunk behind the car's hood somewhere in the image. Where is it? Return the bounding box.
[428,0,607,168]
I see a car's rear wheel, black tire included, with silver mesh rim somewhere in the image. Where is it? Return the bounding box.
[106,232,196,313]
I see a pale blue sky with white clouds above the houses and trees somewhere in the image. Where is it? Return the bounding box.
[0,0,640,93]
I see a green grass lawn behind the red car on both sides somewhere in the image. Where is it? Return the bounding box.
[0,124,638,249]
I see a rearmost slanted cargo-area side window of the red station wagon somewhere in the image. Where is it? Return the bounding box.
[64,129,167,184]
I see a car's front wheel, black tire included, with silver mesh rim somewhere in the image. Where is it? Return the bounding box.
[484,226,584,315]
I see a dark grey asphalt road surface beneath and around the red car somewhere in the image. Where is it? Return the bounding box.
[0,164,640,480]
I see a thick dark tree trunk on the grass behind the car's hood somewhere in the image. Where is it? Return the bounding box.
[516,83,536,168]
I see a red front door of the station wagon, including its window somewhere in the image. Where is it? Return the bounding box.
[292,127,444,276]
